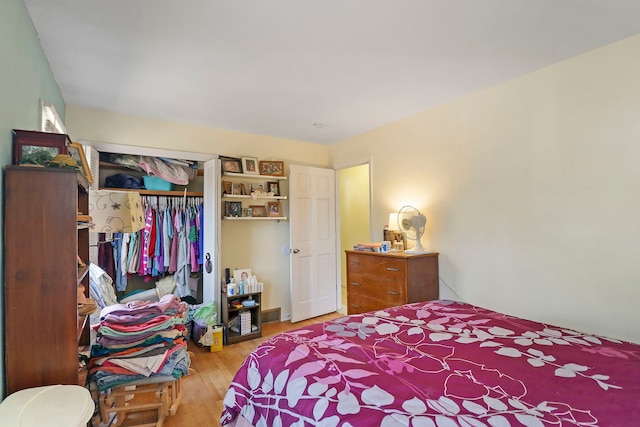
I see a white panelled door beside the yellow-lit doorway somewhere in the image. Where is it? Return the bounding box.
[289,165,337,322]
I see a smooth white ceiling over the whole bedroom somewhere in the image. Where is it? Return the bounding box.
[25,0,640,144]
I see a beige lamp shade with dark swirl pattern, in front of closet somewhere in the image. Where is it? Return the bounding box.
[89,190,144,233]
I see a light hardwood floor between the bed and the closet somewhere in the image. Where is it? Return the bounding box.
[105,313,343,427]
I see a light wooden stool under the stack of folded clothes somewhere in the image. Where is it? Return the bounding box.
[99,376,182,427]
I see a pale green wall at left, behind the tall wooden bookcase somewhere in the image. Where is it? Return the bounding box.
[0,0,65,400]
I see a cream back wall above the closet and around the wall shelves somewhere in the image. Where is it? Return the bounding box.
[66,106,329,317]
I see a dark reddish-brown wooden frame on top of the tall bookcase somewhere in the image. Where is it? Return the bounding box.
[12,130,70,166]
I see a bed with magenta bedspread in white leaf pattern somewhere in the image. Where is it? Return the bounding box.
[220,300,640,427]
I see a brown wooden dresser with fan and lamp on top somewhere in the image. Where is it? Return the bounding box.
[345,251,439,314]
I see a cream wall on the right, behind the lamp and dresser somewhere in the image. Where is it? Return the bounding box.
[331,36,640,342]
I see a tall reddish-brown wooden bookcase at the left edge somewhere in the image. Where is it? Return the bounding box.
[4,160,90,395]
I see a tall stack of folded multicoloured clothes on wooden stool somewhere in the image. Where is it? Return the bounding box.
[89,294,191,391]
